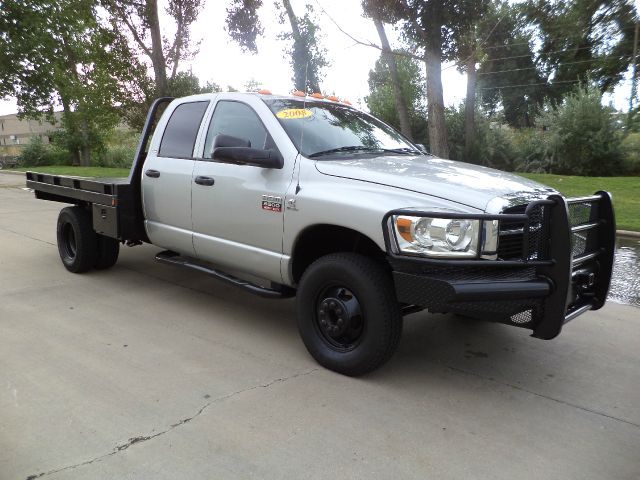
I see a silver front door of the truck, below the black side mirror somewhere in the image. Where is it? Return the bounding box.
[192,97,295,282]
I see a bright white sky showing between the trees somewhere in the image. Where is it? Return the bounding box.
[0,0,630,115]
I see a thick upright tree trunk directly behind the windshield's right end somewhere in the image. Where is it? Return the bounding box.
[425,43,449,158]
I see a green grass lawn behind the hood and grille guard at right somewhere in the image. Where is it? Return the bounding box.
[519,173,640,232]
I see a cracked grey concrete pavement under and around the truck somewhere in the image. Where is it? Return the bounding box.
[0,174,640,480]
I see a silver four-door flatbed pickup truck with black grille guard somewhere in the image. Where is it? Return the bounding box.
[27,92,615,375]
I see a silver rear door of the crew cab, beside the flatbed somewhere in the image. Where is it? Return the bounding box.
[142,101,209,256]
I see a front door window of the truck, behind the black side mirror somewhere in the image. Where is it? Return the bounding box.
[204,101,268,158]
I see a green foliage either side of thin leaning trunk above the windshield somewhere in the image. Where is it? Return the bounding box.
[364,55,428,144]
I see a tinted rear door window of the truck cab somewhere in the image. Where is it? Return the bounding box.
[158,102,209,158]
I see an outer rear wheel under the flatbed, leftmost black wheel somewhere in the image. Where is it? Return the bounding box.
[58,207,98,273]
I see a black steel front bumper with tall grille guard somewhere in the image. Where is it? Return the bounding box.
[383,192,615,339]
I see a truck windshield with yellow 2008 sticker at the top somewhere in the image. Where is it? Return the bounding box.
[265,99,421,159]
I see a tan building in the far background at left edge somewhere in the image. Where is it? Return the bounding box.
[0,112,62,156]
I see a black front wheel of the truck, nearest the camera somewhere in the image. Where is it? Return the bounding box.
[296,253,402,376]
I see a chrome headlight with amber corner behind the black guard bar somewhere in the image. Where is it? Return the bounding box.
[390,215,498,258]
